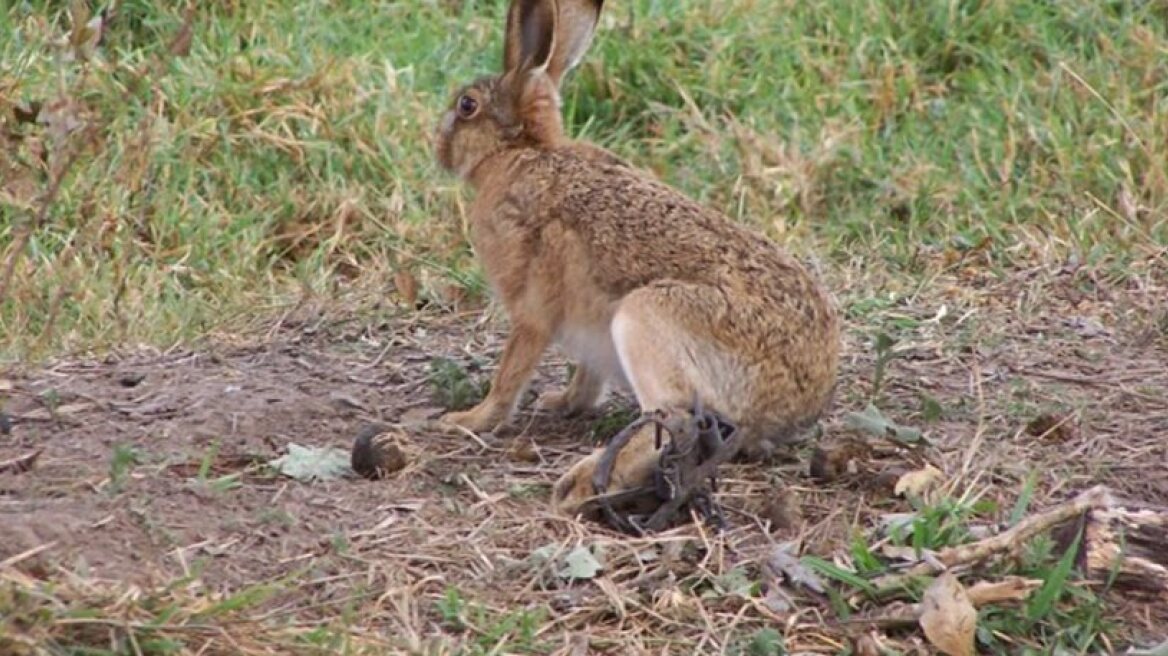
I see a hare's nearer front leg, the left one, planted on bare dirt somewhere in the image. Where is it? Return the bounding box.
[442,323,551,433]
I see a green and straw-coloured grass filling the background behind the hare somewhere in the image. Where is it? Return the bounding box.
[0,0,1168,361]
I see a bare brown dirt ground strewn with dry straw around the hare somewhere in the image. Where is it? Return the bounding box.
[0,262,1168,654]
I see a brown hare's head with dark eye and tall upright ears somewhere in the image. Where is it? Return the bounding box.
[436,0,604,177]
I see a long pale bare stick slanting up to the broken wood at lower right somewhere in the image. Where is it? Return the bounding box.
[871,486,1114,595]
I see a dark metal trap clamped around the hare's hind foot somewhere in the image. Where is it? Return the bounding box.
[592,402,738,535]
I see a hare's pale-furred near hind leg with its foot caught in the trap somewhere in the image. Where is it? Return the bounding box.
[552,281,757,515]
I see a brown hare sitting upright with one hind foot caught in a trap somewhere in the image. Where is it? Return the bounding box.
[434,0,840,515]
